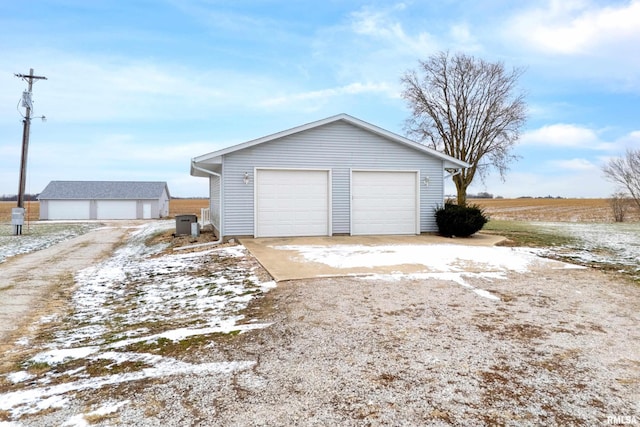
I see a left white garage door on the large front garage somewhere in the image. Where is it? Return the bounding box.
[255,170,330,237]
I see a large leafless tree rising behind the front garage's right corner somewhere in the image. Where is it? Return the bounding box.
[401,52,526,205]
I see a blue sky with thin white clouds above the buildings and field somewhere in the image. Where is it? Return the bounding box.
[0,0,640,197]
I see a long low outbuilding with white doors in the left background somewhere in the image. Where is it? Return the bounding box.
[38,181,170,220]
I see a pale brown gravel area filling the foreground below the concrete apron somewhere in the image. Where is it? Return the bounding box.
[0,229,640,427]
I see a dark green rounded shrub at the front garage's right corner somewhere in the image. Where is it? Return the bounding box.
[435,202,489,237]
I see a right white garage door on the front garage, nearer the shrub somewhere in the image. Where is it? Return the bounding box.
[351,171,420,235]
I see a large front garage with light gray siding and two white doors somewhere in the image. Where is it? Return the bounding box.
[191,114,469,241]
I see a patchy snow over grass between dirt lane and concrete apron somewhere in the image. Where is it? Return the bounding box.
[0,221,275,425]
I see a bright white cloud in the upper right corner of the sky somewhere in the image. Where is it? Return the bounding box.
[497,0,640,93]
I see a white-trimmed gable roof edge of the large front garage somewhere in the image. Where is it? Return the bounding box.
[191,113,470,175]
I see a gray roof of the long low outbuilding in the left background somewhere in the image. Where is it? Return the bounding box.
[38,181,169,200]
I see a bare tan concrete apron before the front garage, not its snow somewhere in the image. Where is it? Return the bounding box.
[240,233,505,282]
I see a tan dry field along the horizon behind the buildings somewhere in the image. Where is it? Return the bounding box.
[0,199,640,223]
